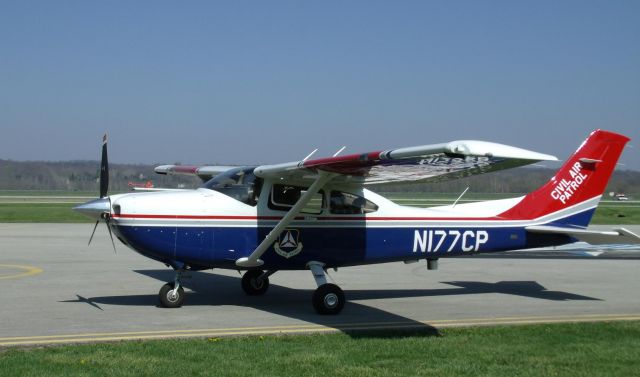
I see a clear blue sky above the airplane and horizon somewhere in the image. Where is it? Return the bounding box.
[0,1,640,170]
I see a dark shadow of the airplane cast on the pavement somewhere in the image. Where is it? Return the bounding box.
[65,270,599,338]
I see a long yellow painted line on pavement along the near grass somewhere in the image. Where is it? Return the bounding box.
[0,314,640,346]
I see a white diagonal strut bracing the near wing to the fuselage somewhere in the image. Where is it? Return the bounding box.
[236,170,336,268]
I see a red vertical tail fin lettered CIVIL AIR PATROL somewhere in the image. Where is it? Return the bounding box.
[500,130,629,227]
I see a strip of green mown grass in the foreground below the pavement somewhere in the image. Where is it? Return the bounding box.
[0,322,640,377]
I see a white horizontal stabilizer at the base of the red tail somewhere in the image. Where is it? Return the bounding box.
[525,225,640,245]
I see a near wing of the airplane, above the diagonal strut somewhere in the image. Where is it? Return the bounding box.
[255,140,557,185]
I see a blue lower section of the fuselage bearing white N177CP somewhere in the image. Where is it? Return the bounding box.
[113,211,593,270]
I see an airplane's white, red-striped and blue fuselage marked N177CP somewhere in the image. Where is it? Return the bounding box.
[110,177,599,270]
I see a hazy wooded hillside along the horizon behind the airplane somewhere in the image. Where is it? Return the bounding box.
[0,160,640,197]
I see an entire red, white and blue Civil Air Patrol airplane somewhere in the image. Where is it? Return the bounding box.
[74,130,640,314]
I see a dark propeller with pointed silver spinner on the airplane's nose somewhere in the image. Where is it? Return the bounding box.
[73,134,118,254]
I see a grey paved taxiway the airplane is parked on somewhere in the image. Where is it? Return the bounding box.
[0,224,640,346]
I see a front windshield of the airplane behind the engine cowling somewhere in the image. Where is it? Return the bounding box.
[200,167,262,206]
